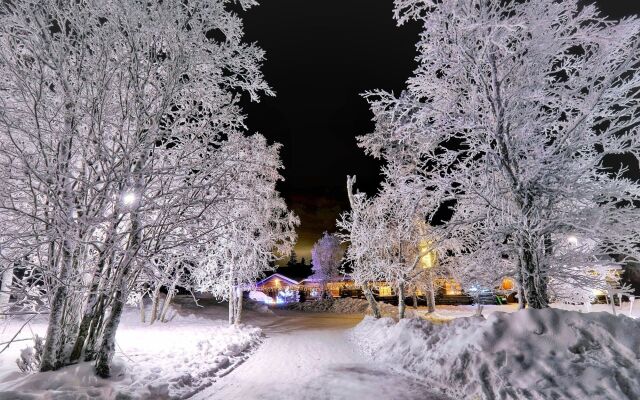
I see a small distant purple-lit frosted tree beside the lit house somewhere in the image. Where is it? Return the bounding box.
[311,232,344,297]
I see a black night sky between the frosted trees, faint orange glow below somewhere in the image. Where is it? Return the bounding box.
[242,0,640,259]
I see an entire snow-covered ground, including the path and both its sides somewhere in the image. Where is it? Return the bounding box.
[0,298,640,400]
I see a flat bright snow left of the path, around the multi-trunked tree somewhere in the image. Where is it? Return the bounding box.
[0,298,270,400]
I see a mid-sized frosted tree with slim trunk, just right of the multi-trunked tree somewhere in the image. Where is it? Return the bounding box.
[192,135,299,324]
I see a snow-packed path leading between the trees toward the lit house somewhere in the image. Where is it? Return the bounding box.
[193,312,446,400]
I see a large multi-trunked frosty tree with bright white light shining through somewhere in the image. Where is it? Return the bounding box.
[0,0,271,376]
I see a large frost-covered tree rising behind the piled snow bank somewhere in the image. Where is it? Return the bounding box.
[361,0,640,308]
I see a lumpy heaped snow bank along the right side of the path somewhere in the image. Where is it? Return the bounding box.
[353,309,640,399]
